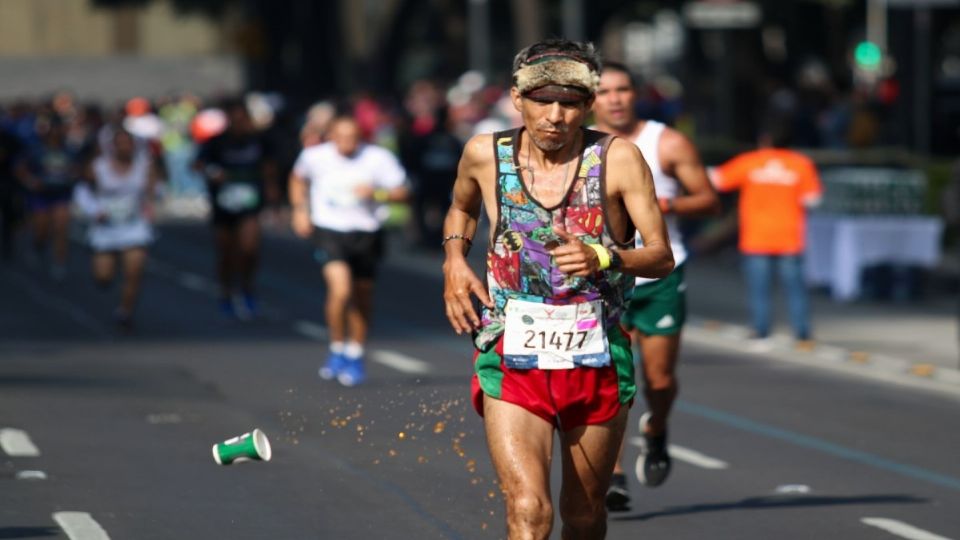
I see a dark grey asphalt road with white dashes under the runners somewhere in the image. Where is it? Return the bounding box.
[0,220,960,540]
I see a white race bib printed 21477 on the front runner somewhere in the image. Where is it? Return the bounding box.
[503,300,610,369]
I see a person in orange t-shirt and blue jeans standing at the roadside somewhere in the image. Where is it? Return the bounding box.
[712,125,823,350]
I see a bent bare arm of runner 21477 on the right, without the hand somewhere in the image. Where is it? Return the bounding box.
[607,139,674,278]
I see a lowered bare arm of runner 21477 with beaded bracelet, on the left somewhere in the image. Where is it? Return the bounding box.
[443,135,493,334]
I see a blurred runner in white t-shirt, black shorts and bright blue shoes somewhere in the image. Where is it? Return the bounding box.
[289,117,408,386]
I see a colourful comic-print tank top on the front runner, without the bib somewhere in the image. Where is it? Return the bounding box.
[474,128,634,350]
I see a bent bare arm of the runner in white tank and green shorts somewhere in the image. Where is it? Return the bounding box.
[659,129,720,217]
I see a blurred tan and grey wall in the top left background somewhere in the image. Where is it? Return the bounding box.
[0,0,245,103]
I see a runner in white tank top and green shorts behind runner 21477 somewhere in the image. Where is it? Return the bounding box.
[593,62,720,511]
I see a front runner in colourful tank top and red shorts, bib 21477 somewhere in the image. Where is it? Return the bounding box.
[443,40,673,539]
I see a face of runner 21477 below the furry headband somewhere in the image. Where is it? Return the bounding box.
[511,87,590,152]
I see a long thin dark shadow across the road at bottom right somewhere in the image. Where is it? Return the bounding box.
[610,495,927,521]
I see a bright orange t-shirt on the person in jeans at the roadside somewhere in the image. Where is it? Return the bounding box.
[714,148,823,255]
